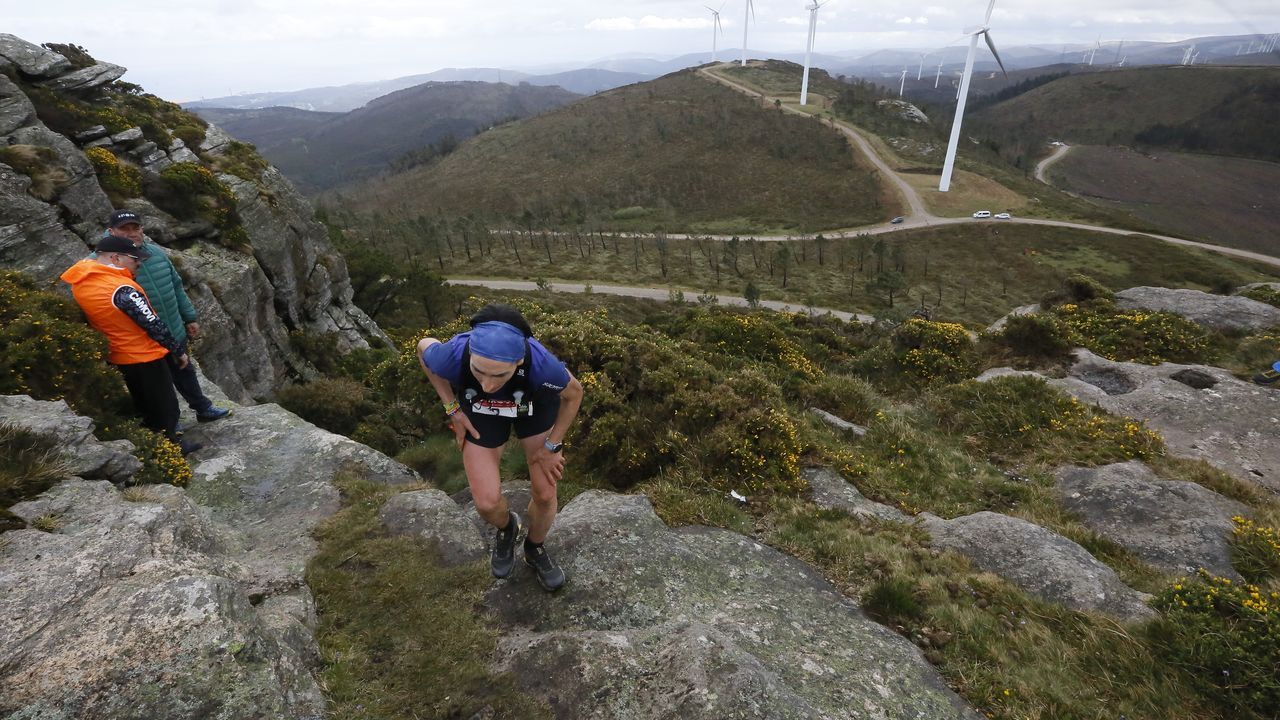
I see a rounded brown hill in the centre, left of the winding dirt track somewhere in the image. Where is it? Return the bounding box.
[334,70,896,232]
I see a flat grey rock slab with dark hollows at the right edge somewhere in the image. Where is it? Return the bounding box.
[1050,350,1280,492]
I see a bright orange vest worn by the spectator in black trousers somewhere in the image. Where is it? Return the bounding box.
[61,260,169,365]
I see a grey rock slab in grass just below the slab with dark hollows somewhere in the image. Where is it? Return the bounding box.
[1057,460,1249,580]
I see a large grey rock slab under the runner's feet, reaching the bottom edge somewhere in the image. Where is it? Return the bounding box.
[486,491,977,720]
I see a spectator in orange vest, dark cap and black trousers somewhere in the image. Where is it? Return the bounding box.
[61,236,200,455]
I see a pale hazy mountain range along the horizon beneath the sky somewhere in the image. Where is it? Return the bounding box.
[186,35,1280,111]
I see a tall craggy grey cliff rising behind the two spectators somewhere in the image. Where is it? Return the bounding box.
[0,35,390,402]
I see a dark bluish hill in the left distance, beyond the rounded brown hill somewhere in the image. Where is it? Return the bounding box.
[200,82,577,192]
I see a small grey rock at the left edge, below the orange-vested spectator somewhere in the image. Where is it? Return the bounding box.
[0,395,142,483]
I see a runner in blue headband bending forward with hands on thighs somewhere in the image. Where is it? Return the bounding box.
[417,305,582,591]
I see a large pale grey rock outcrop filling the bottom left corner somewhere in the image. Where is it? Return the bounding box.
[0,391,416,720]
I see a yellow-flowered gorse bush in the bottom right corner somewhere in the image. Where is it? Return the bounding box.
[1149,570,1280,720]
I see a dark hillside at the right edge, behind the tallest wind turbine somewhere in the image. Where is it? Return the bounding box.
[966,67,1280,160]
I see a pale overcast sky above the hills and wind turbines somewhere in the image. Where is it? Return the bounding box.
[10,0,1280,101]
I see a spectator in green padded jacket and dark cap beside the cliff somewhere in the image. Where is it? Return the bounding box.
[104,210,230,423]
